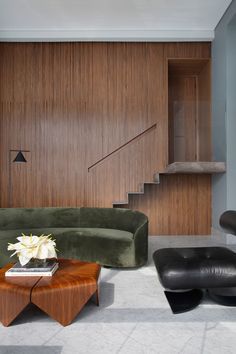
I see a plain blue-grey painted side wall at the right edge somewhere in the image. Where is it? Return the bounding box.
[212,0,236,228]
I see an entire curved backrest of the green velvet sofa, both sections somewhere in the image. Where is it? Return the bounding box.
[0,207,147,233]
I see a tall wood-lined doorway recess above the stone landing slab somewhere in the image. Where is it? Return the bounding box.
[168,59,211,164]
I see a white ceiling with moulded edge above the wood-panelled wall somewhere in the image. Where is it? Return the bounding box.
[0,0,232,42]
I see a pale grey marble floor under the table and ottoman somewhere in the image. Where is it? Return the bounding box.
[0,236,236,354]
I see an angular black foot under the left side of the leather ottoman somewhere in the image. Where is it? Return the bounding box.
[164,289,203,314]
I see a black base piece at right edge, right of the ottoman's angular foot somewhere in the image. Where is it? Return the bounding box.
[207,288,236,306]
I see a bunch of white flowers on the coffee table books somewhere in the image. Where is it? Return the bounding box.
[7,234,57,265]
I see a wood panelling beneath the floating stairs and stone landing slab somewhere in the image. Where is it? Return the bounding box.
[117,174,211,235]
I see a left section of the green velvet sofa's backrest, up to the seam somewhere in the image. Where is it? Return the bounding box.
[0,208,80,230]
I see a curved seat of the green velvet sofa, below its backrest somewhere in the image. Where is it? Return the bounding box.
[0,227,133,266]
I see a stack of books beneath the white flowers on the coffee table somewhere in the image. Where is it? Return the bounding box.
[5,259,58,277]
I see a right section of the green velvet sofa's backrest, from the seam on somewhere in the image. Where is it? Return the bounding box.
[80,207,148,233]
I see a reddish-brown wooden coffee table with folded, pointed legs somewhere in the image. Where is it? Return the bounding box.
[0,259,101,326]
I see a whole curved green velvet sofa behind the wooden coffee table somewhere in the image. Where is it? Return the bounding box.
[0,207,148,267]
